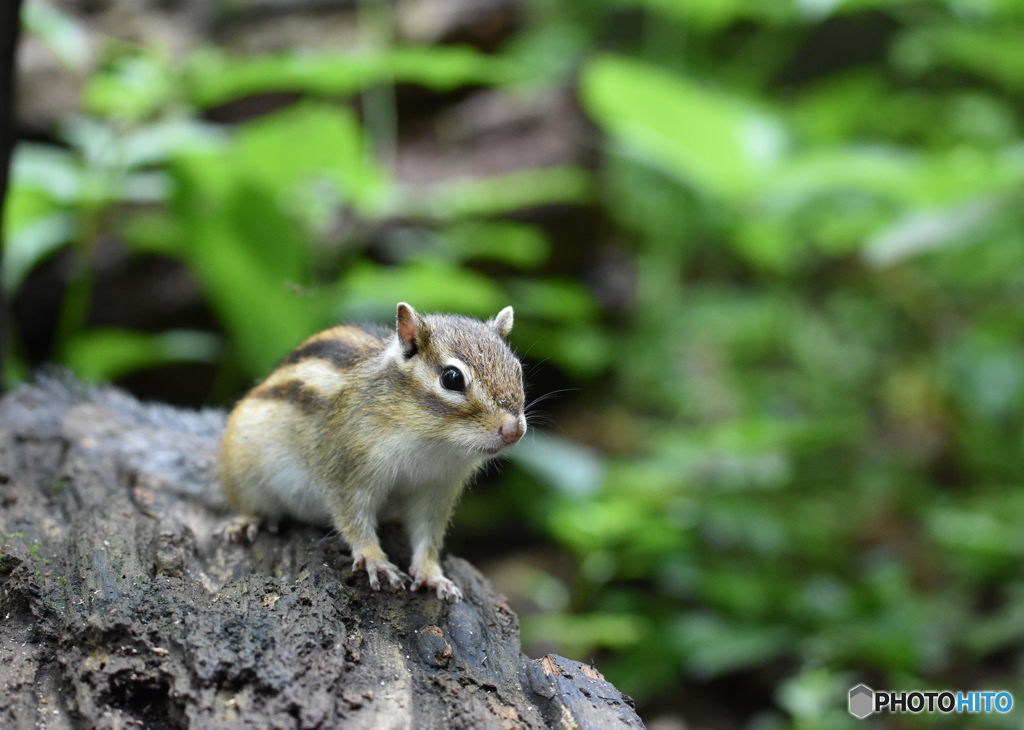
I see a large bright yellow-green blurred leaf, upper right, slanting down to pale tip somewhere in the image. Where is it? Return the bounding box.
[580,55,783,198]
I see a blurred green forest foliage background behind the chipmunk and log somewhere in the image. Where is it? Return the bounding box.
[2,0,1024,730]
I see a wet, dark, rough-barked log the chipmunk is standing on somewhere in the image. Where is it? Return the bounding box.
[0,379,643,730]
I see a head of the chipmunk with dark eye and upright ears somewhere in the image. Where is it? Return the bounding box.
[397,302,526,456]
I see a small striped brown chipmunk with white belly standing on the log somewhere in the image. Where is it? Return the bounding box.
[220,302,526,603]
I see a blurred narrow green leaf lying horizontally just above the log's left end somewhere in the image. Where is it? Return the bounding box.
[63,329,220,382]
